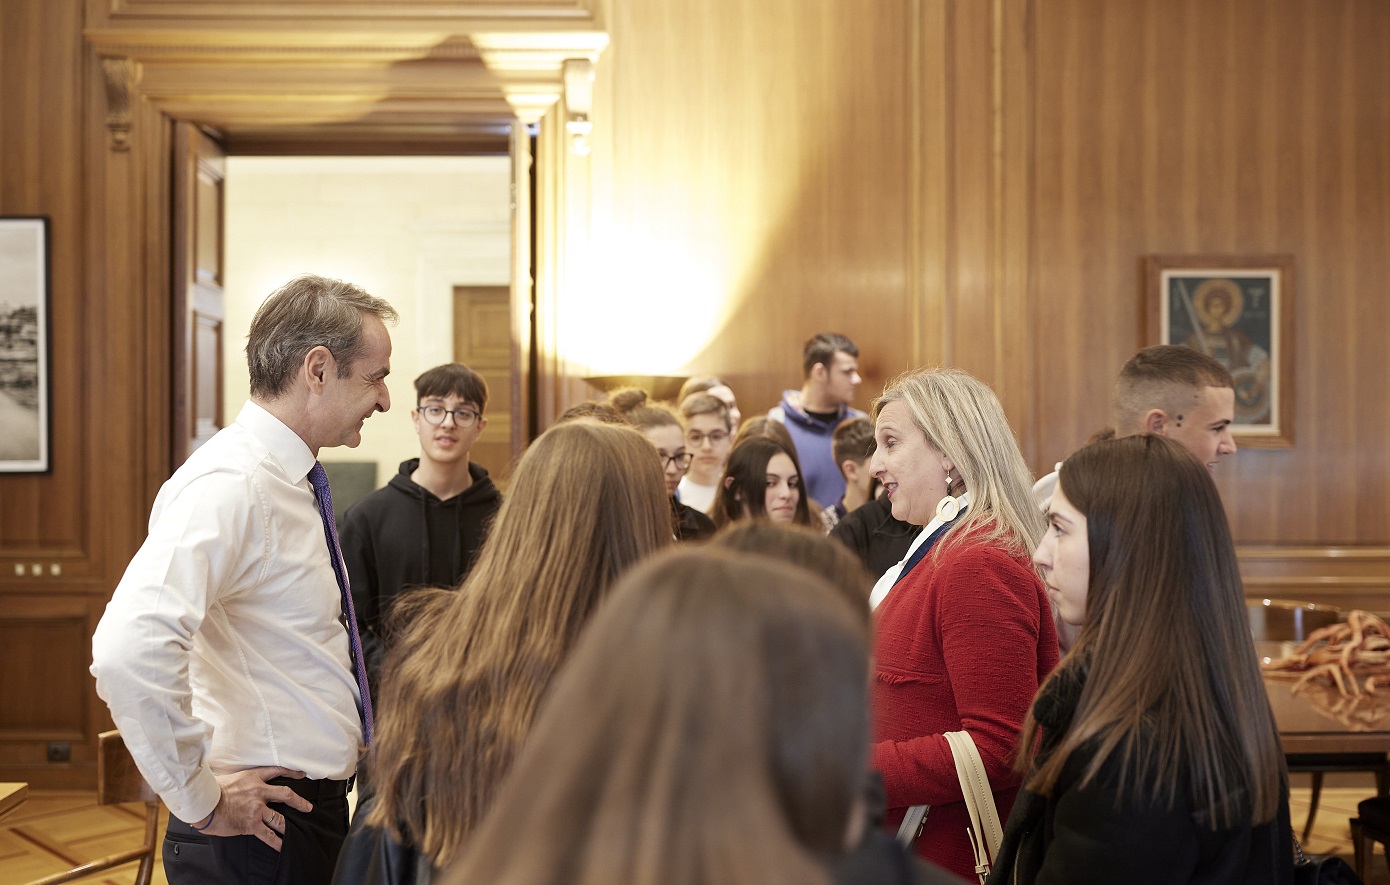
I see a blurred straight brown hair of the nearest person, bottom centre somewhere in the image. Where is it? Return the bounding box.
[441,547,869,885]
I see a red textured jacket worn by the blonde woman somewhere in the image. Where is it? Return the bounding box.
[872,527,1058,881]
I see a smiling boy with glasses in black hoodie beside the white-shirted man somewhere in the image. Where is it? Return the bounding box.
[342,363,502,708]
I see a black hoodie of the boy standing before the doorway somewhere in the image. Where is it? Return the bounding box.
[341,458,502,695]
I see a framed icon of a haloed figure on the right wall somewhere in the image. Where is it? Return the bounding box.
[1144,256,1294,449]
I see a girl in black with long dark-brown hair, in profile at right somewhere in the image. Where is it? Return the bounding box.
[990,435,1293,885]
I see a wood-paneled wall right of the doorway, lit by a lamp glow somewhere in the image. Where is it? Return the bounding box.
[595,0,1390,552]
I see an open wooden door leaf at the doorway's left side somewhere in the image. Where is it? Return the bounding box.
[171,121,227,468]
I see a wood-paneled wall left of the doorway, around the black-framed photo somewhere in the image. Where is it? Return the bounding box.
[0,0,111,786]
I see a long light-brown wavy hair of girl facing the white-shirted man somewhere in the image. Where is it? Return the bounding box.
[367,420,671,863]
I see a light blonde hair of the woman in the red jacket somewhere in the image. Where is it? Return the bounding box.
[873,368,1044,556]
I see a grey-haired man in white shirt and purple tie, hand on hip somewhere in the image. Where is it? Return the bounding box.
[92,276,396,885]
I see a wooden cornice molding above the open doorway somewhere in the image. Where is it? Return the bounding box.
[83,18,609,138]
